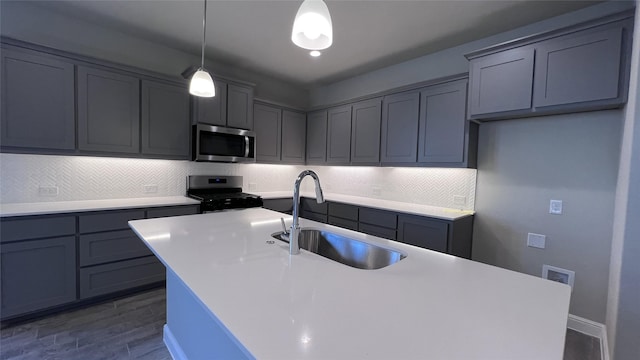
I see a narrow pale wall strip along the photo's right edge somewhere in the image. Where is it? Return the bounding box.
[607,2,640,360]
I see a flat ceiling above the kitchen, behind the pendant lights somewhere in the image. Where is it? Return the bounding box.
[31,0,596,88]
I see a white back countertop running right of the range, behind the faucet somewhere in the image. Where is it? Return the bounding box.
[253,191,474,220]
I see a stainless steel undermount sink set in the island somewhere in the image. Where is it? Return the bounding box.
[271,228,407,270]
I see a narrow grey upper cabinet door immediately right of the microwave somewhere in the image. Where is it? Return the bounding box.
[253,104,282,162]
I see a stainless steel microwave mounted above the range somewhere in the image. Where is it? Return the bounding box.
[191,123,256,162]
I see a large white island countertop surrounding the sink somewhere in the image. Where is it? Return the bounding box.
[129,209,571,360]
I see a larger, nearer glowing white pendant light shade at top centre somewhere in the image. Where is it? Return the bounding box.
[291,0,333,50]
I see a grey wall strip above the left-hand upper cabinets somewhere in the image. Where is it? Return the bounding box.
[0,0,309,108]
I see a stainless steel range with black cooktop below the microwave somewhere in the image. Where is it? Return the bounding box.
[187,175,262,213]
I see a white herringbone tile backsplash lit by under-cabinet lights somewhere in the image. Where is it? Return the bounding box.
[0,153,476,210]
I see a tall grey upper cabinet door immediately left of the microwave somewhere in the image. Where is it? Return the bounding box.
[142,80,190,159]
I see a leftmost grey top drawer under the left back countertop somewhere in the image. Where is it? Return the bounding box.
[0,216,76,243]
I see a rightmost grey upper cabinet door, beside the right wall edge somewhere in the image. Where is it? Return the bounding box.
[533,27,622,107]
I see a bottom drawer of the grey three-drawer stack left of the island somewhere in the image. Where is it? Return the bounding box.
[80,256,165,299]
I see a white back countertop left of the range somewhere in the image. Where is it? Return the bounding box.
[0,196,200,217]
